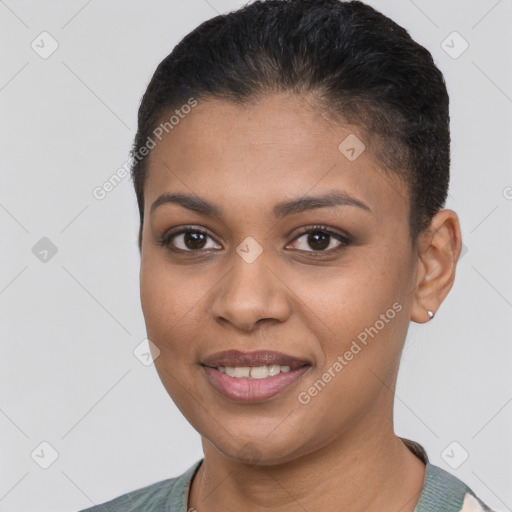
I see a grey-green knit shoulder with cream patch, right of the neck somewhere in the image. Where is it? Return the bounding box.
[415,463,494,512]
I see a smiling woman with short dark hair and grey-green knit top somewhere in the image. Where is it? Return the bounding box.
[79,0,496,512]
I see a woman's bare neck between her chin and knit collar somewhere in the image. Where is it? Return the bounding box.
[189,416,425,512]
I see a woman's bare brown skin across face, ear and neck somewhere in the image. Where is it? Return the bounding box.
[140,94,461,512]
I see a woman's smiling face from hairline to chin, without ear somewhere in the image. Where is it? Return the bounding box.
[140,95,417,464]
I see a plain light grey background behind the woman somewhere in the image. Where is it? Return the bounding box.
[0,0,512,512]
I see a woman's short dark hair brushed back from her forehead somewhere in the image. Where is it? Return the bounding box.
[131,0,450,250]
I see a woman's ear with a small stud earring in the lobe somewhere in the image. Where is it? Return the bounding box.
[411,210,462,323]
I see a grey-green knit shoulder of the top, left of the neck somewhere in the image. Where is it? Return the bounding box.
[79,460,202,512]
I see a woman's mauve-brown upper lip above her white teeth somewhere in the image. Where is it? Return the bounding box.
[202,350,311,370]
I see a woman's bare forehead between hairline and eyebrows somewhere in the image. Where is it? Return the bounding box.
[145,94,408,218]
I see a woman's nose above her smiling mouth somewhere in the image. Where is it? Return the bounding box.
[211,248,291,331]
